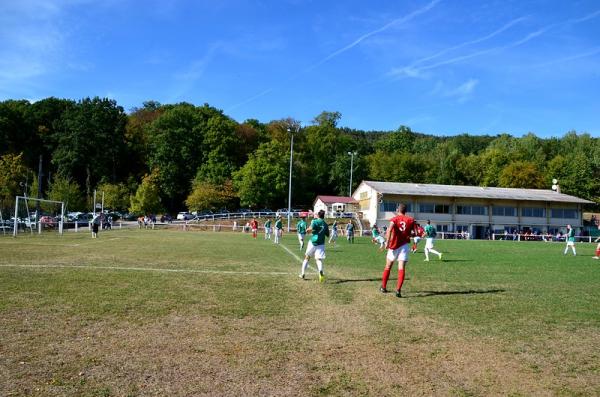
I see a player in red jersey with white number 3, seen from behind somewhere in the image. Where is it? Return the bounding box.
[379,204,416,298]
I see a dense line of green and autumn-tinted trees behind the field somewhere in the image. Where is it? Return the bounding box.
[0,97,600,214]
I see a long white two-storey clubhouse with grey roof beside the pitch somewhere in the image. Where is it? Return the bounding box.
[352,181,593,239]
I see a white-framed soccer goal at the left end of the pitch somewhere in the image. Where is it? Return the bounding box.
[13,196,65,237]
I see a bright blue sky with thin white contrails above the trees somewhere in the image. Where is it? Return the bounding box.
[0,0,600,137]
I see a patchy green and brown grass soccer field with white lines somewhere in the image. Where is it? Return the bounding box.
[0,230,600,396]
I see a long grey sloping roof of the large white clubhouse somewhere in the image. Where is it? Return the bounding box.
[362,181,593,204]
